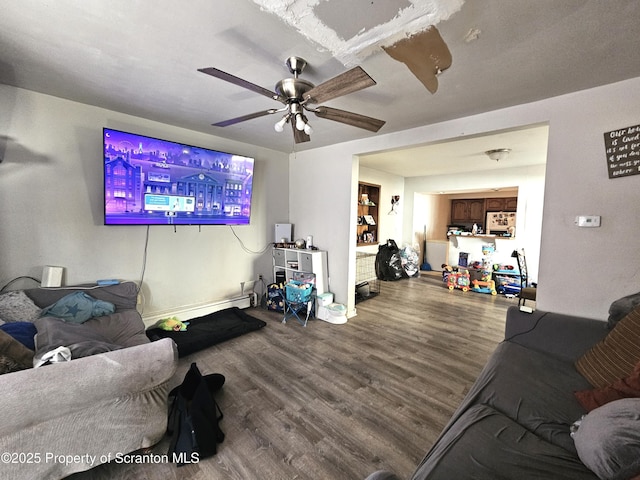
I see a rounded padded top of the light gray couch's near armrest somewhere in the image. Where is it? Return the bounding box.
[0,339,178,438]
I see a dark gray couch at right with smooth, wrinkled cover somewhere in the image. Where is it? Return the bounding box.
[367,307,620,480]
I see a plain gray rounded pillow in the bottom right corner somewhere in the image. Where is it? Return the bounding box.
[573,398,640,480]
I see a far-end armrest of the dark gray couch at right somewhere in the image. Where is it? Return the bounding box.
[505,307,609,362]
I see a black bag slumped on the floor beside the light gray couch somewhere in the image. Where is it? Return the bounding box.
[167,363,225,467]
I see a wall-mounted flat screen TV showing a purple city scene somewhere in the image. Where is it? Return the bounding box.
[103,128,254,225]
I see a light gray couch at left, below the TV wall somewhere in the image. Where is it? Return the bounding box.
[0,282,177,479]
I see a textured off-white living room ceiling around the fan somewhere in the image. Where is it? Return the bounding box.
[0,0,640,171]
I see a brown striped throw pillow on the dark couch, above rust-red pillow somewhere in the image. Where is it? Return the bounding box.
[575,305,640,388]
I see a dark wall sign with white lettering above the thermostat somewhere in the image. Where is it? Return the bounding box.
[604,125,640,178]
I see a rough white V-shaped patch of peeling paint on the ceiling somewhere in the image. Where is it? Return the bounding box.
[253,0,464,67]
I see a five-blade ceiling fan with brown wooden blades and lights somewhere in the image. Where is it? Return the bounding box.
[198,57,385,143]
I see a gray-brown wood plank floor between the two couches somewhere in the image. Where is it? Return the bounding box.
[70,274,517,480]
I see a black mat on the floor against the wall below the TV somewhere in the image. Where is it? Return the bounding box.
[147,307,266,358]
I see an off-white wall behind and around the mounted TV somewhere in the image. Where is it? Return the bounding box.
[0,85,289,314]
